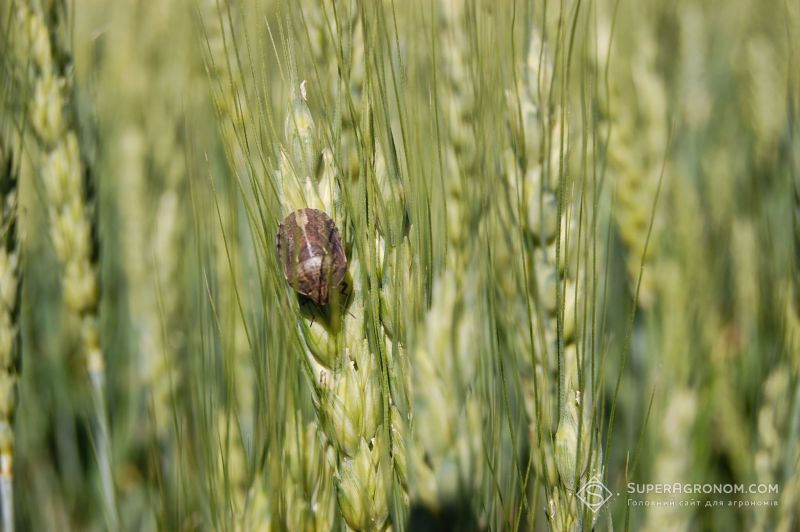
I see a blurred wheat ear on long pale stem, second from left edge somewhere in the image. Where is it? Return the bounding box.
[13,1,119,529]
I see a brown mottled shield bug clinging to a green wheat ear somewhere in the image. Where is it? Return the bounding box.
[275,209,347,305]
